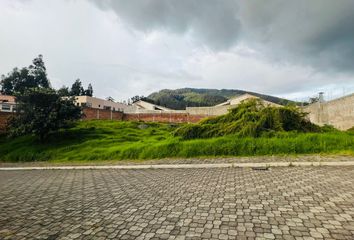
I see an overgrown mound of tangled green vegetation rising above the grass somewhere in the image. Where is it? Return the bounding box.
[174,99,320,139]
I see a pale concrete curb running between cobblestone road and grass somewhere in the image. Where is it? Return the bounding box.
[0,161,354,171]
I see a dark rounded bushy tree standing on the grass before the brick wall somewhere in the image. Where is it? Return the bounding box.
[9,88,81,142]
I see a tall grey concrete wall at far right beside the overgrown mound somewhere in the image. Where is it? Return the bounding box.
[304,94,354,130]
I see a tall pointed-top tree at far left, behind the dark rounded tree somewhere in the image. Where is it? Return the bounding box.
[0,55,50,95]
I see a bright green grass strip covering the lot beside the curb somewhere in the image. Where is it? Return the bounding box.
[0,120,354,162]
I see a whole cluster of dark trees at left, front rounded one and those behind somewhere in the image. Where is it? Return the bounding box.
[0,55,93,142]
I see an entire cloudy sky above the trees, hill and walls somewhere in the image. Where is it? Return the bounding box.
[0,0,354,100]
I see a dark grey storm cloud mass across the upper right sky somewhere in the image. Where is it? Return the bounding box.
[93,0,354,71]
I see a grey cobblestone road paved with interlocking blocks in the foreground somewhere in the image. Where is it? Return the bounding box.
[0,167,354,239]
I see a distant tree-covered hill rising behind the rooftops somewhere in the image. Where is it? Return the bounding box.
[147,88,294,109]
